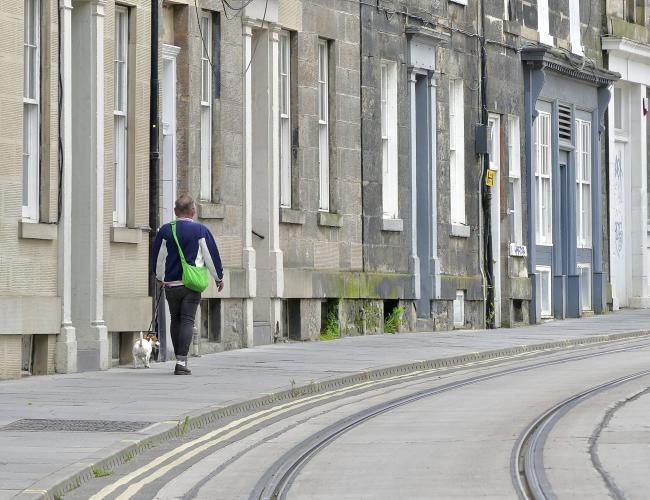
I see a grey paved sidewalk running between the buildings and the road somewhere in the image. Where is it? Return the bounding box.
[0,310,650,499]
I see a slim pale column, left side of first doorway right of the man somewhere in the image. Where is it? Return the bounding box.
[242,20,257,347]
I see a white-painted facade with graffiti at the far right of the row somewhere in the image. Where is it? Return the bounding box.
[602,0,650,309]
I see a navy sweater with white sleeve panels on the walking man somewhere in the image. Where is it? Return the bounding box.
[152,219,223,284]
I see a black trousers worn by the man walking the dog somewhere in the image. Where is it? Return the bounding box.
[165,286,201,361]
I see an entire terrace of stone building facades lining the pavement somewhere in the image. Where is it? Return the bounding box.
[0,0,632,377]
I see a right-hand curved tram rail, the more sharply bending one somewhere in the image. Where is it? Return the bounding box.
[511,370,650,500]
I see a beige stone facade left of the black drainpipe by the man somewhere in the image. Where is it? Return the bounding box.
[0,0,151,378]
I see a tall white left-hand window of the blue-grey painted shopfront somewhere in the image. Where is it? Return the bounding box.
[535,111,553,245]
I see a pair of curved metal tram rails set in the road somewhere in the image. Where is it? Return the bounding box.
[249,343,650,500]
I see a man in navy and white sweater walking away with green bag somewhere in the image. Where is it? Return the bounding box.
[153,194,223,375]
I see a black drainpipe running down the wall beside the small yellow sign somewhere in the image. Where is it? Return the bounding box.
[479,1,498,328]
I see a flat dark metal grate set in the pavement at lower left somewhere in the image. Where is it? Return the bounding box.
[0,418,152,432]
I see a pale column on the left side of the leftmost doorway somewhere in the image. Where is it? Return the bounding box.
[55,0,77,373]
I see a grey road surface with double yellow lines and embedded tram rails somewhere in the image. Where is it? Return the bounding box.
[65,340,650,499]
